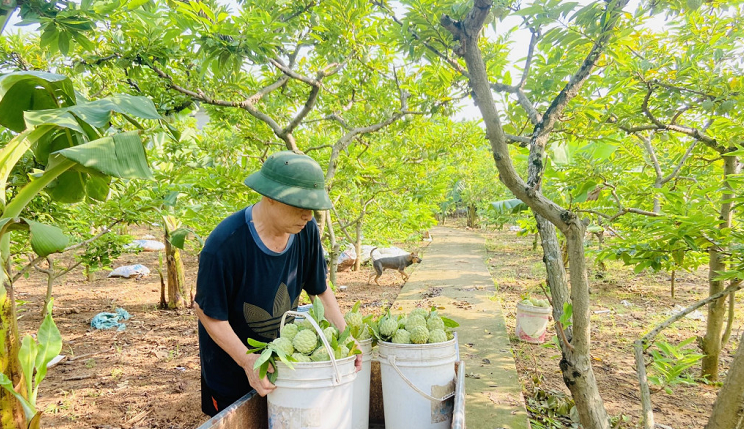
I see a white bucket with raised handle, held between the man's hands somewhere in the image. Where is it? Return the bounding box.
[267,311,357,429]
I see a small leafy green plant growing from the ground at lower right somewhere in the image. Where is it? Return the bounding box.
[648,337,703,395]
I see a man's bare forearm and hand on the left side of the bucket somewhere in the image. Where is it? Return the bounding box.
[194,302,276,396]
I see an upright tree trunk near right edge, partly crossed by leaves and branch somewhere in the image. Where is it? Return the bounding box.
[700,155,739,381]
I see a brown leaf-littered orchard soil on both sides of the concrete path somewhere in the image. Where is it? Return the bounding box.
[16,221,744,429]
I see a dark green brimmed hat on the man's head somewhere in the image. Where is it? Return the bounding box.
[245,150,331,210]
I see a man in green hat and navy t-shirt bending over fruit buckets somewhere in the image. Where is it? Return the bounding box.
[190,151,361,416]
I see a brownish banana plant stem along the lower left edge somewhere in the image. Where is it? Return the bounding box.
[0,246,28,429]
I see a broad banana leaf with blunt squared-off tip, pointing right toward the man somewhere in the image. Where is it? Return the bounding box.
[47,132,153,179]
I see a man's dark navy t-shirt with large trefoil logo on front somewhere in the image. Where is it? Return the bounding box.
[195,206,326,400]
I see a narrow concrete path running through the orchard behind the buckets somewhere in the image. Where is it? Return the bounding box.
[392,227,530,429]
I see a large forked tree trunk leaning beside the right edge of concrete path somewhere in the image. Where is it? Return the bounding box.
[440,0,628,429]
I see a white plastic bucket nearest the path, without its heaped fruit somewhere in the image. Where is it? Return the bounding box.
[378,338,457,429]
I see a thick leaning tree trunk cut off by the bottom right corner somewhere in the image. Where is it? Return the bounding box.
[705,334,744,429]
